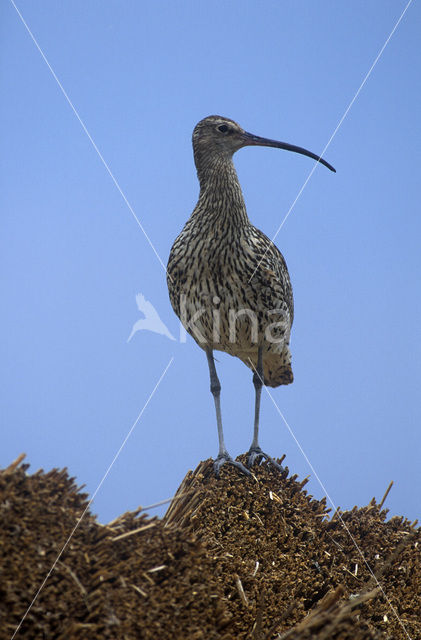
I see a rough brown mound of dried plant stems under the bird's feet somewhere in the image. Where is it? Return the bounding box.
[0,461,421,640]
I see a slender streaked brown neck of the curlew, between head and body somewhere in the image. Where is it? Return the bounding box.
[193,154,250,227]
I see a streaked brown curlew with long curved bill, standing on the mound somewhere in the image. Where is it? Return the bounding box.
[167,115,335,476]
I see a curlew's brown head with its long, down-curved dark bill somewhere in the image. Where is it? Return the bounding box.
[193,116,335,171]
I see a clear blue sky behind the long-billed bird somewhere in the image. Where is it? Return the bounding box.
[0,0,421,522]
